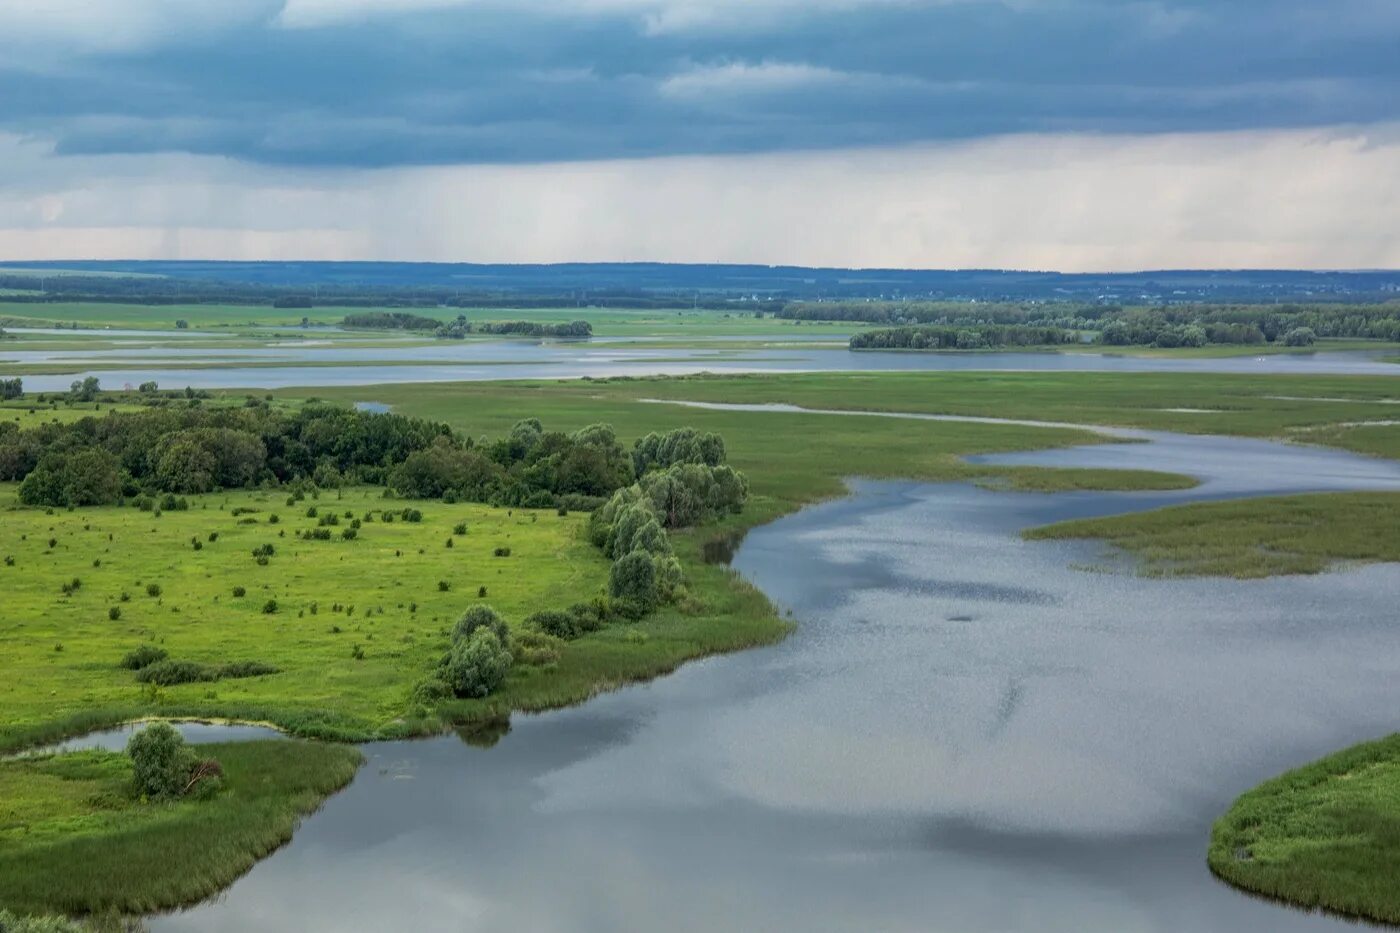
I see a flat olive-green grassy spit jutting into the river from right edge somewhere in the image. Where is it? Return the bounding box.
[1025,493,1400,579]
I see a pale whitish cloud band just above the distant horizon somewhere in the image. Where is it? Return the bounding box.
[0,127,1400,270]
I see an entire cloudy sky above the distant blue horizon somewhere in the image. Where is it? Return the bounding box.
[0,0,1400,270]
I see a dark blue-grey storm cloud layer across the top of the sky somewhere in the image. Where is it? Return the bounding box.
[0,0,1400,167]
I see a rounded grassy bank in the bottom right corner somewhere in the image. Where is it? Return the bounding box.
[1207,734,1400,923]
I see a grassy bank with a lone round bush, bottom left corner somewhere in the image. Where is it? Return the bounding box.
[0,741,363,915]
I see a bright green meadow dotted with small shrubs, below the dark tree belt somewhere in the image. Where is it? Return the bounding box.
[0,485,608,748]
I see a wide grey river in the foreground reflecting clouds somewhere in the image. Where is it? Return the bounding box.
[153,413,1400,933]
